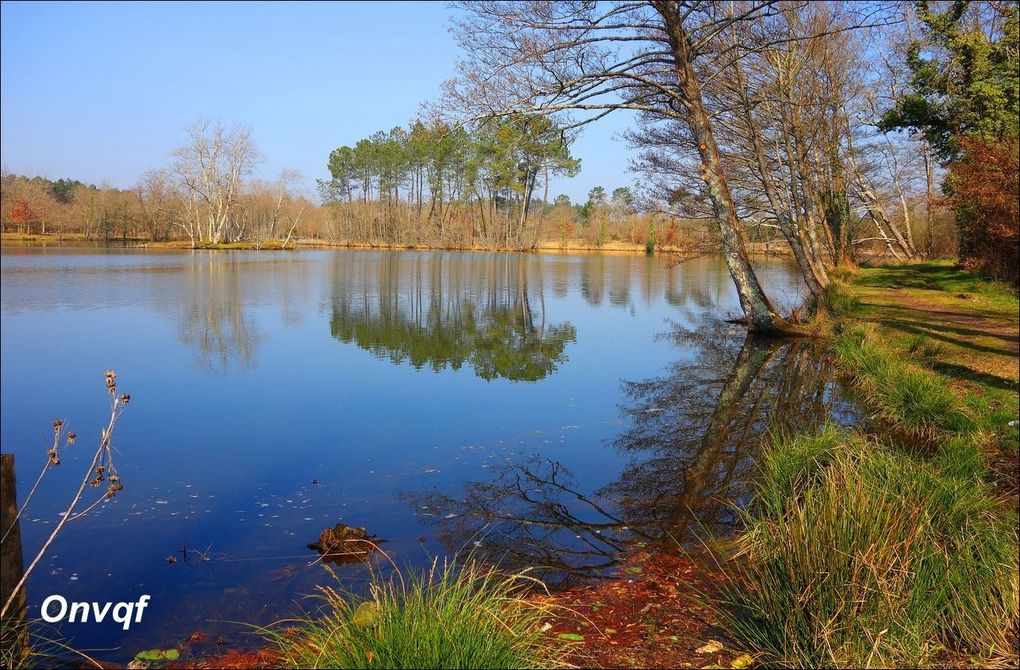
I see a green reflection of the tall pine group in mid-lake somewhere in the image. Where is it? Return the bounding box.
[329,254,576,381]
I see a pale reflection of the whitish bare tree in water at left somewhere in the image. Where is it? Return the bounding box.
[179,255,262,372]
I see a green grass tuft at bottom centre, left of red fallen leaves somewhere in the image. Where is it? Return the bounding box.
[272,562,562,668]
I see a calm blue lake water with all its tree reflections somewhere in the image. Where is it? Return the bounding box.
[0,245,848,660]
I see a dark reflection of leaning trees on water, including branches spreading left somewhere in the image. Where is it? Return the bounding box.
[405,322,843,581]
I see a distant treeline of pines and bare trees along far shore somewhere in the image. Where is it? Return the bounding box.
[0,116,734,250]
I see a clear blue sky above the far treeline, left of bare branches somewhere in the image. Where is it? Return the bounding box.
[0,2,634,202]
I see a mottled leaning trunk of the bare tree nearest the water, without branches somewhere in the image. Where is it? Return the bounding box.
[654,2,797,334]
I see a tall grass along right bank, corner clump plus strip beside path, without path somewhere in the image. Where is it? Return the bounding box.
[708,268,1020,667]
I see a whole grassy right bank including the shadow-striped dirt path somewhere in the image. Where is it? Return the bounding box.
[716,263,1020,667]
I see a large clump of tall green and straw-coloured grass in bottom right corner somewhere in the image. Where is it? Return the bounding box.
[715,426,1020,667]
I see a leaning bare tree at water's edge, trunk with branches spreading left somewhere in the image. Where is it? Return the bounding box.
[447,1,811,332]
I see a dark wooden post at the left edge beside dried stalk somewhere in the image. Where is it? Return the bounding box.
[0,454,29,665]
